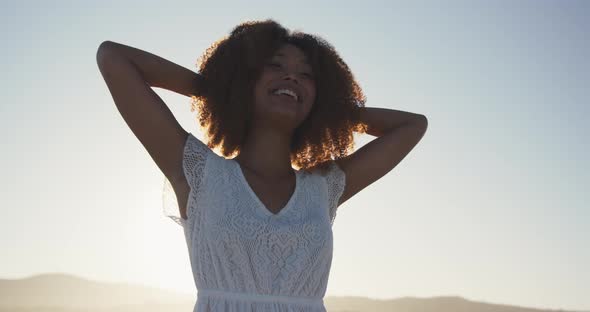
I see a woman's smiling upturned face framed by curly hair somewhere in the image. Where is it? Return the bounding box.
[254,44,316,130]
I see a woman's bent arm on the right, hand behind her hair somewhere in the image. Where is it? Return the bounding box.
[335,107,428,205]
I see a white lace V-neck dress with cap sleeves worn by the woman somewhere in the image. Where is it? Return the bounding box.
[164,133,345,312]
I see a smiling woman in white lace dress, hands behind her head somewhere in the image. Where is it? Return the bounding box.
[97,20,427,311]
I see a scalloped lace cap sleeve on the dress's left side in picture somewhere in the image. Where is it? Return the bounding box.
[162,132,213,227]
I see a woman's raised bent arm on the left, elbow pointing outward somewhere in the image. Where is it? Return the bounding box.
[96,41,204,184]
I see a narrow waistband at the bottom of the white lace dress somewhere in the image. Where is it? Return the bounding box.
[197,289,324,306]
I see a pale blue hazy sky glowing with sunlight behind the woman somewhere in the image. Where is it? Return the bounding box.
[0,1,590,310]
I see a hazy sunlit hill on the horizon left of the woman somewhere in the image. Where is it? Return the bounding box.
[0,274,196,312]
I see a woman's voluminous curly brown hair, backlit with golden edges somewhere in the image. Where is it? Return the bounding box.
[191,19,367,170]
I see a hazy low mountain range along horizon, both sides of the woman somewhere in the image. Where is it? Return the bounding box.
[0,274,590,312]
